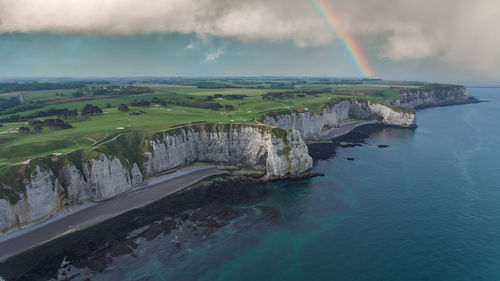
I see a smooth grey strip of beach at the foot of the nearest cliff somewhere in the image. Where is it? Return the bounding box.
[0,166,226,260]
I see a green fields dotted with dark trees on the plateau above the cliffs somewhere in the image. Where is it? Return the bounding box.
[0,78,446,167]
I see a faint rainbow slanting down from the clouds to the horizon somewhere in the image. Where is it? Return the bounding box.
[311,0,377,77]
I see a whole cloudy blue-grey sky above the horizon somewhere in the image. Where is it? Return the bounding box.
[0,0,500,83]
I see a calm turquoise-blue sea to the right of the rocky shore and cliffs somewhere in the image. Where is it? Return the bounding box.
[95,89,500,281]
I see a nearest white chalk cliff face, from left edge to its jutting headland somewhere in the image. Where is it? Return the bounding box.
[0,124,312,233]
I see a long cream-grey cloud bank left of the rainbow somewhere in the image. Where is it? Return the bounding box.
[0,0,333,46]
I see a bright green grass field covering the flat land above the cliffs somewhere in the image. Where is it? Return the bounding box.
[0,79,452,166]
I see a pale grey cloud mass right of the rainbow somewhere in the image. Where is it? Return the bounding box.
[334,0,500,76]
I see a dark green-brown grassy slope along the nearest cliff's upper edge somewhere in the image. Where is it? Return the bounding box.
[0,120,290,201]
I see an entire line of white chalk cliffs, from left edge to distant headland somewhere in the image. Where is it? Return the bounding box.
[0,87,467,235]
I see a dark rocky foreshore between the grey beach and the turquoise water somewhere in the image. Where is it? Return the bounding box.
[0,170,310,280]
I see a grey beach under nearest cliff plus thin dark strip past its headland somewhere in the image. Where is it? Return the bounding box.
[0,163,318,262]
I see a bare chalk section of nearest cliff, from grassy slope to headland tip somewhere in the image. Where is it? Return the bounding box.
[145,126,312,177]
